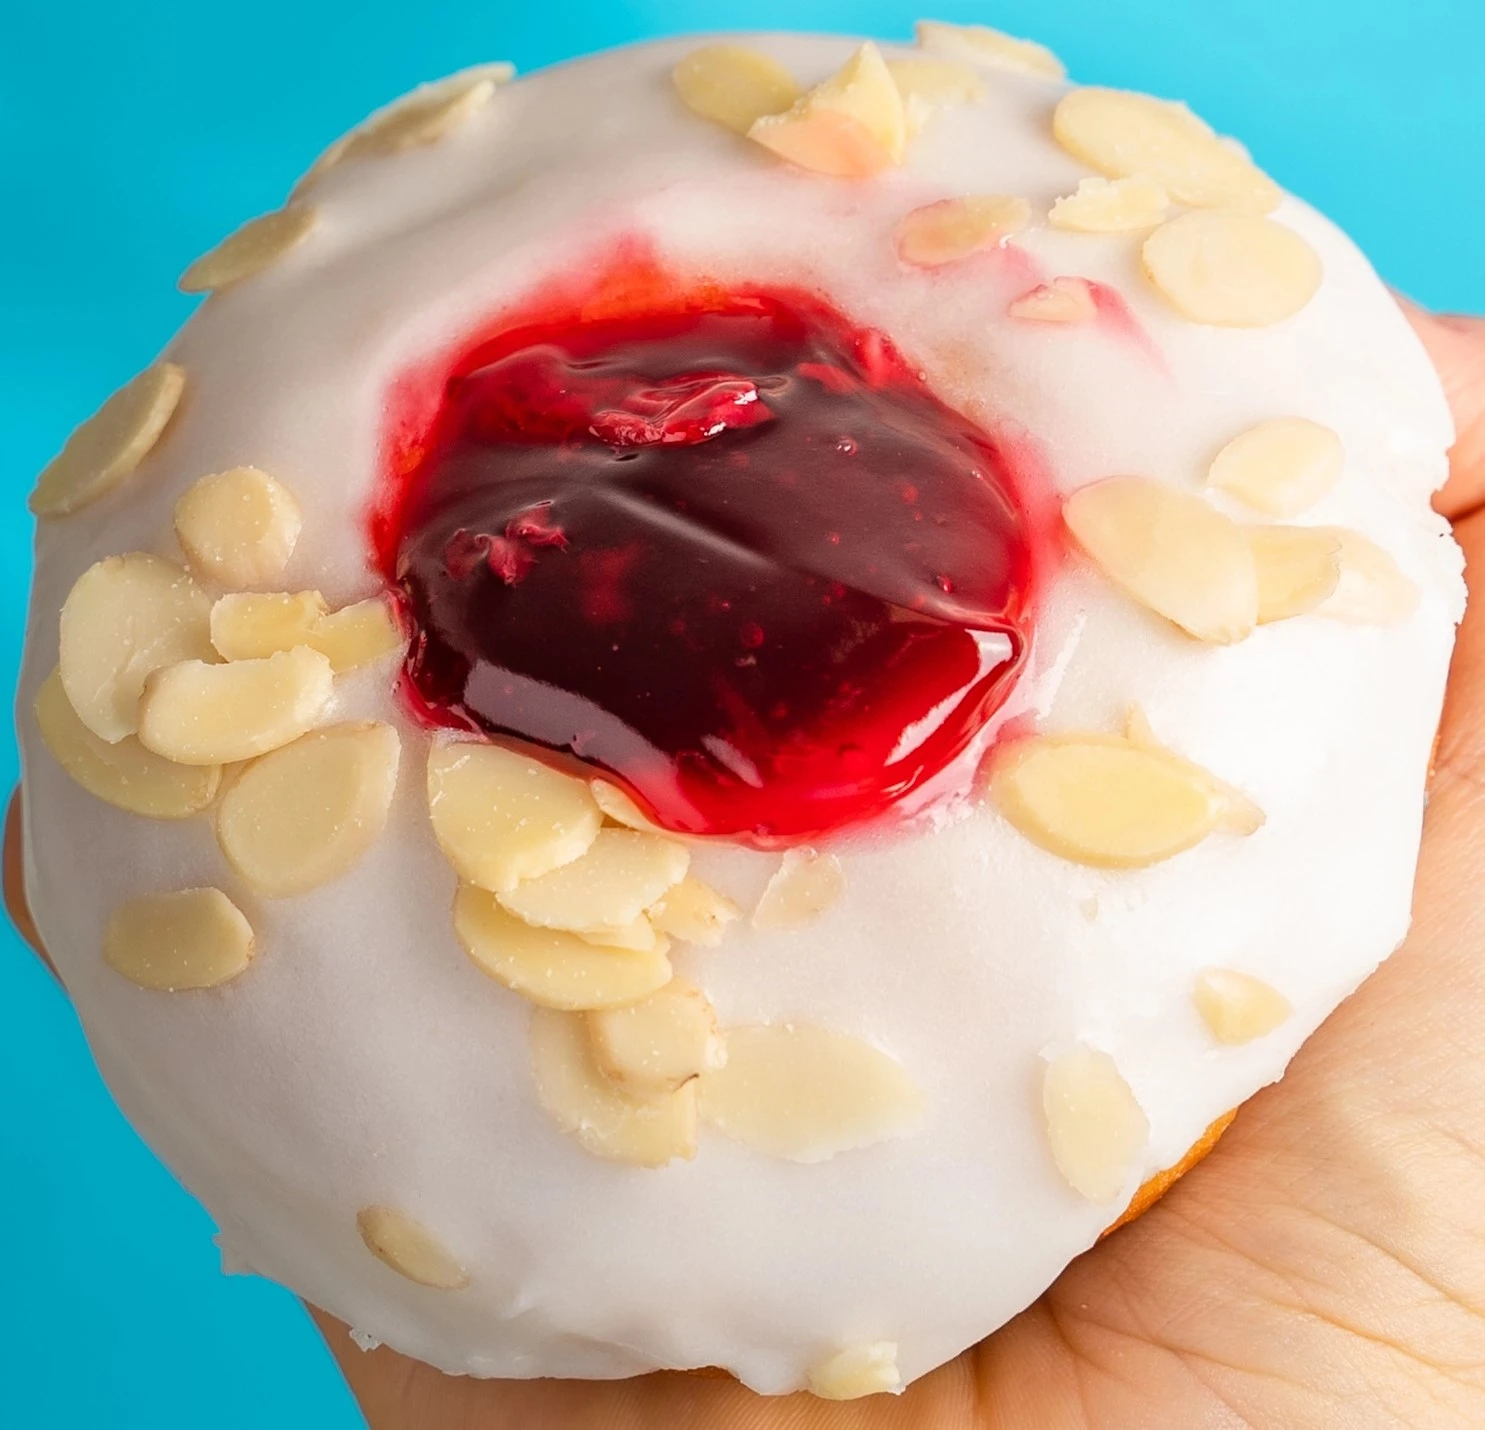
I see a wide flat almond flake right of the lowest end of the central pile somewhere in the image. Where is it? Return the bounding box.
[699,1023,924,1163]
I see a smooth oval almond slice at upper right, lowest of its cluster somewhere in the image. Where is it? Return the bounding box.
[1143,209,1325,328]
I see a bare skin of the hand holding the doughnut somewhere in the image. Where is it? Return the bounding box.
[6,307,1485,1430]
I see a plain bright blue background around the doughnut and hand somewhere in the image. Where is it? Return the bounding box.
[0,0,1485,1430]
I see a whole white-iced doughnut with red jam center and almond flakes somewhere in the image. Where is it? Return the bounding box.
[21,25,1463,1397]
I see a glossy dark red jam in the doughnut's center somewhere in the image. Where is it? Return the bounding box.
[383,286,1034,843]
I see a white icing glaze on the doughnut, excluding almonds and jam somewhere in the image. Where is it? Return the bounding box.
[19,36,1463,1393]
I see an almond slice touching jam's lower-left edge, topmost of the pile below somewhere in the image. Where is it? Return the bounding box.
[428,740,603,894]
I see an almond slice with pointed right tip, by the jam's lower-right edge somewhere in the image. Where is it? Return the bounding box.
[989,735,1262,869]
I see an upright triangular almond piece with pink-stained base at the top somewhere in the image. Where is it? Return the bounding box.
[747,40,907,178]
